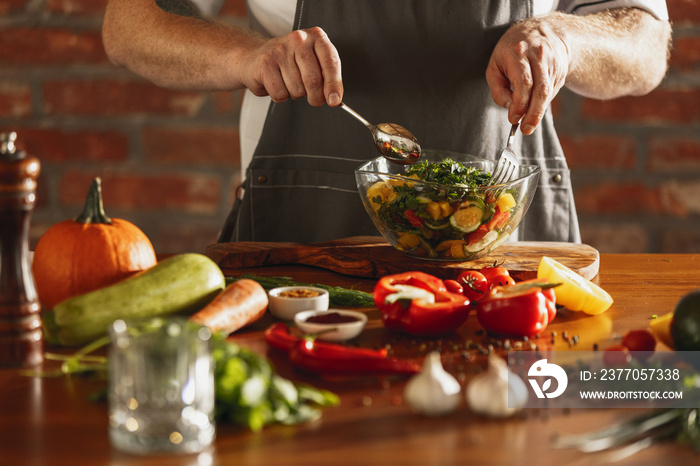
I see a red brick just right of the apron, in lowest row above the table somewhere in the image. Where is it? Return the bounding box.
[581,221,649,254]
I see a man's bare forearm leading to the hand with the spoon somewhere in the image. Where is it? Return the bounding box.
[102,0,264,90]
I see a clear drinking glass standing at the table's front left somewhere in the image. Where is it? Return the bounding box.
[109,318,215,454]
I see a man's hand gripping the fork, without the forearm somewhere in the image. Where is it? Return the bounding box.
[486,20,570,134]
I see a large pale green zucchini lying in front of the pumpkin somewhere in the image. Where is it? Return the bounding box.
[53,253,226,345]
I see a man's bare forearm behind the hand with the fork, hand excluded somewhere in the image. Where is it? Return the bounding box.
[535,8,671,99]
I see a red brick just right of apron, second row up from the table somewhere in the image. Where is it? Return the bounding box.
[574,182,667,215]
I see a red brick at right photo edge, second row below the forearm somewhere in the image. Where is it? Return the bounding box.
[647,138,700,173]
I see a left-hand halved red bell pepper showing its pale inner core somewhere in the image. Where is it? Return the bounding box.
[374,272,471,336]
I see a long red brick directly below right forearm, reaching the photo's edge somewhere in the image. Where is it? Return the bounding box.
[581,88,700,125]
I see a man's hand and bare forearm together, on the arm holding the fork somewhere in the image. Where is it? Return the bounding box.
[486,8,671,135]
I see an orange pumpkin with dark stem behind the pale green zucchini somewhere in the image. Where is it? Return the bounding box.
[32,178,156,309]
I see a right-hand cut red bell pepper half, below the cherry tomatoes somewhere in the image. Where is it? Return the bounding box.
[476,279,557,336]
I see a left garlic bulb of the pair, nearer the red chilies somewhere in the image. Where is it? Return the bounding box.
[404,351,462,416]
